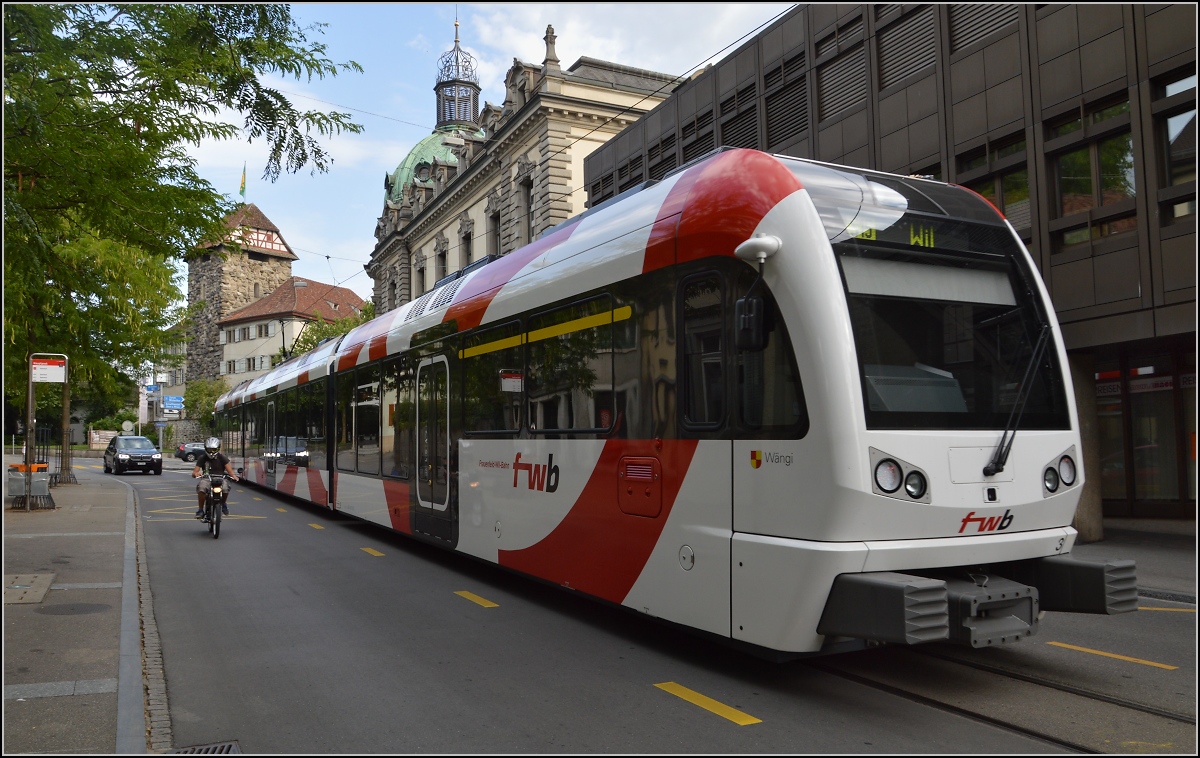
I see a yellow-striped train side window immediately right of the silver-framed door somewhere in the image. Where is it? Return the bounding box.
[458,321,524,433]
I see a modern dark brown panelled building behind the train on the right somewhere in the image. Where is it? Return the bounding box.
[584,4,1196,520]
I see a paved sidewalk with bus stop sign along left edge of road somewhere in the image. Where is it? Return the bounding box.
[4,455,170,754]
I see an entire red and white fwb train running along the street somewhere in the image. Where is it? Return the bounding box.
[216,149,1136,654]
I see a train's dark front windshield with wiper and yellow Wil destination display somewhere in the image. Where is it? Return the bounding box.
[781,158,1069,429]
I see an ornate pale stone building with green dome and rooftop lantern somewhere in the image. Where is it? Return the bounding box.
[365,22,683,313]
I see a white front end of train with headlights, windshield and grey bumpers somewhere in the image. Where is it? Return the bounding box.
[731,158,1136,652]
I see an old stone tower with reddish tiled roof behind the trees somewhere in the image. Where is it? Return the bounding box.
[187,203,296,381]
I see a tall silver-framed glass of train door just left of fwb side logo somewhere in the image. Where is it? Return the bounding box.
[415,355,450,513]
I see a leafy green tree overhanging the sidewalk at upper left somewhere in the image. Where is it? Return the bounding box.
[4,4,361,407]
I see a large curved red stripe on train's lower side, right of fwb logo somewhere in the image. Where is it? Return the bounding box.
[498,440,697,603]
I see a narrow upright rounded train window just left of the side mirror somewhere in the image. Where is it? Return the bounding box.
[679,273,726,428]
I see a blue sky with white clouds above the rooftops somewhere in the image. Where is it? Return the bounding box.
[185,2,792,300]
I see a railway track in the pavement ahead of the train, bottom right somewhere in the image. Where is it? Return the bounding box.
[809,648,1196,754]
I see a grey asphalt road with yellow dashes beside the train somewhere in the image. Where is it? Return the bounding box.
[126,461,1195,754]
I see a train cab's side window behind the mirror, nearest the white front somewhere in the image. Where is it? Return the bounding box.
[736,271,809,438]
